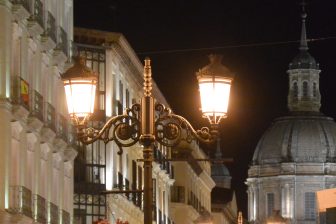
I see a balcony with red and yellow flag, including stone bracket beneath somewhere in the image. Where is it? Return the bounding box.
[11,76,30,119]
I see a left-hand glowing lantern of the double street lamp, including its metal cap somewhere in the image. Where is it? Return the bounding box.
[61,57,98,125]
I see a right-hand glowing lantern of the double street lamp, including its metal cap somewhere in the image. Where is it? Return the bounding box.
[196,54,233,125]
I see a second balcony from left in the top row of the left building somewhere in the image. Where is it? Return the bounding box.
[27,0,44,37]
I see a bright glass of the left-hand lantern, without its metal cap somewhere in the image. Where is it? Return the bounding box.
[64,80,96,118]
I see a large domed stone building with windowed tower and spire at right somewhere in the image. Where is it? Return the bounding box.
[246,7,336,224]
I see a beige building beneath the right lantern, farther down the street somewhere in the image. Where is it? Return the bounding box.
[170,142,215,224]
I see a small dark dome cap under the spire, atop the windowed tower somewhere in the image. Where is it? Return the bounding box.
[289,50,319,69]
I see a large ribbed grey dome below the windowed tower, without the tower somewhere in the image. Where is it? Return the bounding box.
[253,115,336,165]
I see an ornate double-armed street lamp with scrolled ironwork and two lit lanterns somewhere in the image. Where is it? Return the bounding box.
[62,55,232,224]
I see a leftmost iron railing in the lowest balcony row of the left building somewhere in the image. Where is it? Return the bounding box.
[10,186,32,217]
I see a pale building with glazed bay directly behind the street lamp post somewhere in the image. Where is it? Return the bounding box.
[74,28,174,224]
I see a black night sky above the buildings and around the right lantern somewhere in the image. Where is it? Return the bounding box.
[74,0,336,216]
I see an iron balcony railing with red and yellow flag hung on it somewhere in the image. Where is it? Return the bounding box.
[12,76,30,110]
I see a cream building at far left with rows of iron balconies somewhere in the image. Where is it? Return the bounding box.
[0,0,77,224]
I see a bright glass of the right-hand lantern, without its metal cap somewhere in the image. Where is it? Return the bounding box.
[199,77,231,116]
